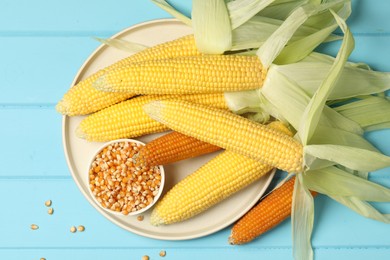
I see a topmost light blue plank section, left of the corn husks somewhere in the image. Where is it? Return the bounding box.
[0,0,171,35]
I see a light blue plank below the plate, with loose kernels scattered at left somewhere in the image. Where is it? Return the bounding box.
[0,178,390,249]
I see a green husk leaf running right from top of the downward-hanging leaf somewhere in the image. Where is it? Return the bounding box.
[304,166,390,202]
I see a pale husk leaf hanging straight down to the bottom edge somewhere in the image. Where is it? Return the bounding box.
[291,174,314,259]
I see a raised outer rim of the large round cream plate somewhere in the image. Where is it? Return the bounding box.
[61,18,276,241]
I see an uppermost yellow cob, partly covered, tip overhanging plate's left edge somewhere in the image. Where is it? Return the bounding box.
[56,35,200,116]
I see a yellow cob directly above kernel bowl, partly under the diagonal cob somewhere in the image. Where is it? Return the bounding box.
[76,94,227,142]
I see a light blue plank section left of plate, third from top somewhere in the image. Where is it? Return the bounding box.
[0,106,69,178]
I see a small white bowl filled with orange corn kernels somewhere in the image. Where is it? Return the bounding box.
[88,139,165,216]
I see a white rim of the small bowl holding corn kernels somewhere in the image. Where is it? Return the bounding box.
[87,139,165,216]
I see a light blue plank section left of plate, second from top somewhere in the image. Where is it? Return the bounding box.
[0,37,99,105]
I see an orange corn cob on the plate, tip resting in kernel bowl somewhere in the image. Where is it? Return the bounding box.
[137,132,221,167]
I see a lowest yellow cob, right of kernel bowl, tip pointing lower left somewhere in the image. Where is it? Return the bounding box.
[151,123,291,225]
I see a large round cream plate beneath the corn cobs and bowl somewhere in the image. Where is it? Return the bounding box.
[62,19,274,240]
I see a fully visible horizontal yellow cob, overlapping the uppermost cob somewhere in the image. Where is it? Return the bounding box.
[93,55,264,94]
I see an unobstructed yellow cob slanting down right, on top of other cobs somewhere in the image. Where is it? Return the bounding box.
[144,100,303,173]
